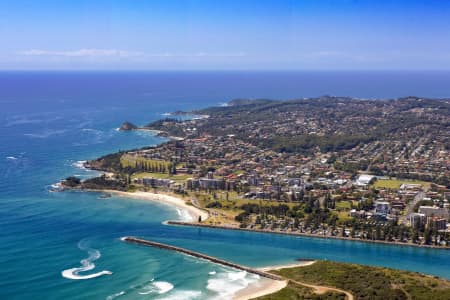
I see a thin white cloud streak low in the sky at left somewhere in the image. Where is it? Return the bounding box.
[18,48,144,57]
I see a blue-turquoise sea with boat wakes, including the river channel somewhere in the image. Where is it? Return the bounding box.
[0,72,450,299]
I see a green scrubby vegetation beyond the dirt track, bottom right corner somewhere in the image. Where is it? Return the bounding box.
[263,261,450,300]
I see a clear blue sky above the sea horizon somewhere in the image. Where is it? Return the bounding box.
[0,0,450,70]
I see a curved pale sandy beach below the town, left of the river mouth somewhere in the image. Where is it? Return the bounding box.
[103,190,209,222]
